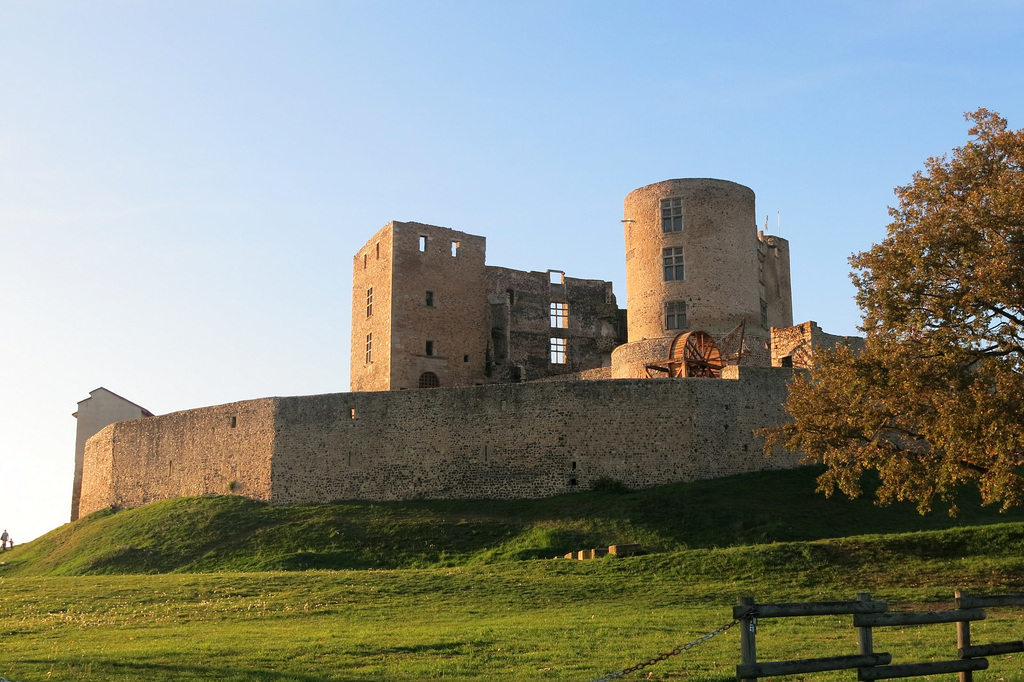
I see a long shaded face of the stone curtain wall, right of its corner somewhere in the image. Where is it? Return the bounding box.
[273,368,800,504]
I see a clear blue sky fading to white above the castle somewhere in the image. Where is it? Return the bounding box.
[6,0,1024,542]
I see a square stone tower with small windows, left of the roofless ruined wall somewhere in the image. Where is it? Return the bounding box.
[351,221,490,391]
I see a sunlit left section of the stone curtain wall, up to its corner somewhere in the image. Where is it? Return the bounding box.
[81,398,276,516]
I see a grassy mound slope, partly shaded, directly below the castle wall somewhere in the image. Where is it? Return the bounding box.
[8,468,1024,577]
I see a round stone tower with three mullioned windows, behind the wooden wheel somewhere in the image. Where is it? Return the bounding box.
[612,178,793,376]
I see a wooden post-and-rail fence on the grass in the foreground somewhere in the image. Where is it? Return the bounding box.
[733,590,1024,682]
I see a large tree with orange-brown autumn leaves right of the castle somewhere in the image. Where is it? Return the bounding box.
[762,109,1024,513]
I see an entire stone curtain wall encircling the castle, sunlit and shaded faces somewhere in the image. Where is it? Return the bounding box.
[75,367,800,514]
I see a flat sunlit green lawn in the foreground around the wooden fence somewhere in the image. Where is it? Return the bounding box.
[0,522,1024,682]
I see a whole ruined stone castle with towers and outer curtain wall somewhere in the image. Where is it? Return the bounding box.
[72,178,857,519]
